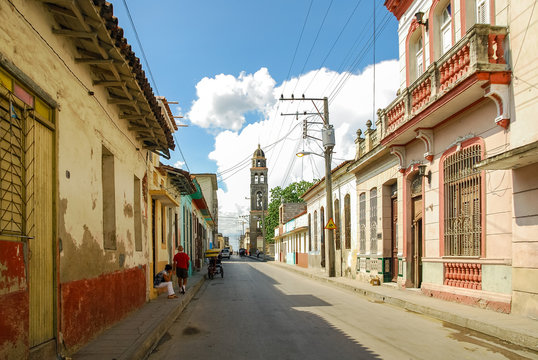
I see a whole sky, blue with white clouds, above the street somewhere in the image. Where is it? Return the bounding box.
[113,0,399,243]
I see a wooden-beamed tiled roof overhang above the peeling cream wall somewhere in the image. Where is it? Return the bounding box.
[38,0,175,159]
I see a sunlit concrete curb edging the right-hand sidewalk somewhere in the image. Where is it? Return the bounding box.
[269,262,538,349]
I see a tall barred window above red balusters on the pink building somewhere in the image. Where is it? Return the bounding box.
[443,145,482,256]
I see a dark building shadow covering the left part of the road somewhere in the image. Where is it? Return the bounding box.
[163,257,380,359]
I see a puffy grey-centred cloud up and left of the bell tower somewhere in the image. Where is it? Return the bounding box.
[187,68,275,131]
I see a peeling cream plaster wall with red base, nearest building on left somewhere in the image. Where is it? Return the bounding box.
[0,0,150,358]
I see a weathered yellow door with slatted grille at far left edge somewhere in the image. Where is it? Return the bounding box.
[0,76,56,347]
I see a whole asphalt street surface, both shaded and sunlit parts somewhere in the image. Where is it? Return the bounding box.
[150,255,538,360]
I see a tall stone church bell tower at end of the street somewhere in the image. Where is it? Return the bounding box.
[250,144,269,253]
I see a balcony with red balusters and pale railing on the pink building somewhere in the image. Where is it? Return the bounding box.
[379,24,511,146]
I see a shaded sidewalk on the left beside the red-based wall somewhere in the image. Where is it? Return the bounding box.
[71,268,206,360]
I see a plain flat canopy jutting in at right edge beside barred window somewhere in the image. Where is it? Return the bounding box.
[474,141,538,170]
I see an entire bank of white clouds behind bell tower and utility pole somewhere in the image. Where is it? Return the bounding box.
[193,60,399,238]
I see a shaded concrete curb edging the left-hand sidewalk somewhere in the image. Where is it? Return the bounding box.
[118,276,205,360]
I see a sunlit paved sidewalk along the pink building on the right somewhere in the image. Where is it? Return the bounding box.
[268,261,538,350]
